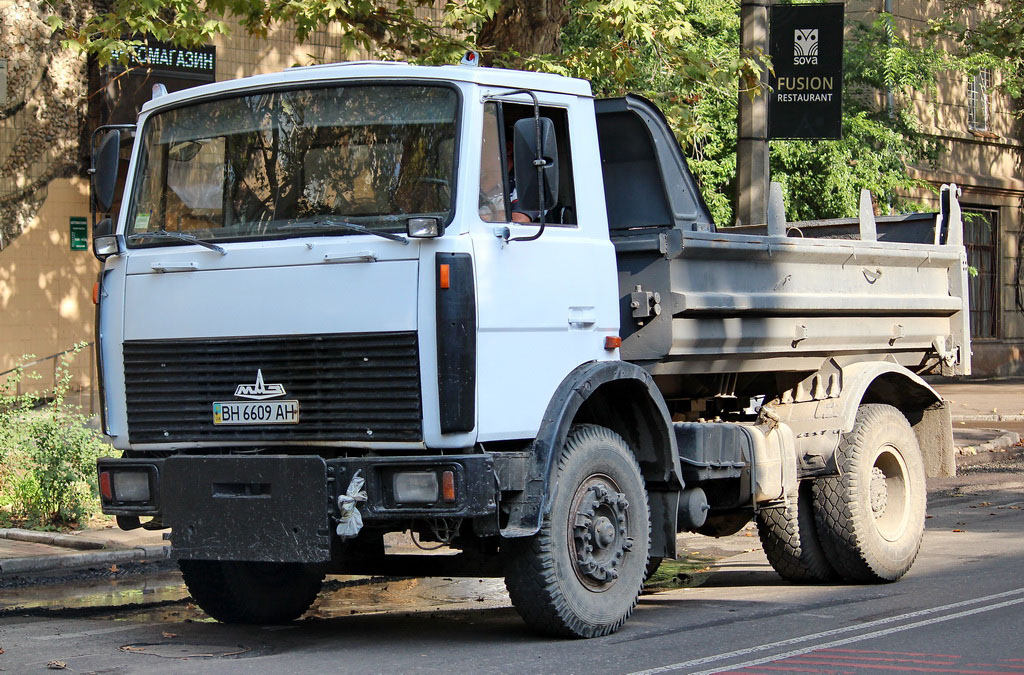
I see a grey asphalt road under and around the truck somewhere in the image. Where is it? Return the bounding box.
[0,450,1024,674]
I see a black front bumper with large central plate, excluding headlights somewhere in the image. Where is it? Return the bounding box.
[98,454,500,562]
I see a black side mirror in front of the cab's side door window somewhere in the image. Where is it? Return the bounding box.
[513,117,558,213]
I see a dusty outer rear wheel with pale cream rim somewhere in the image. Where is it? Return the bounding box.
[814,404,927,583]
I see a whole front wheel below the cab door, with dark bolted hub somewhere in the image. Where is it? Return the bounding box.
[505,424,650,637]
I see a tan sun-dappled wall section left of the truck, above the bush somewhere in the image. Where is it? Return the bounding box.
[0,178,99,386]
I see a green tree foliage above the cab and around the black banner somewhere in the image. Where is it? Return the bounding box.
[49,0,999,224]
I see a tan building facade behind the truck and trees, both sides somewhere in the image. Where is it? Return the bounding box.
[0,0,1024,386]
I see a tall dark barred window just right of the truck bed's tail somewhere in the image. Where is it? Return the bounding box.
[964,208,998,338]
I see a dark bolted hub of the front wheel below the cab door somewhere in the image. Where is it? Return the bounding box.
[572,480,633,590]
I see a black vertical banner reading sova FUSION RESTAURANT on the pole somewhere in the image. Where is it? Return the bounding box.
[768,2,844,139]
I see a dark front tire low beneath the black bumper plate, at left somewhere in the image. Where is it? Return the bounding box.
[178,560,324,624]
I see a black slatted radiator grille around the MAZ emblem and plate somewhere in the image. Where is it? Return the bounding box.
[124,332,423,444]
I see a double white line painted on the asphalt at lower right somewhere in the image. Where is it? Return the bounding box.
[630,588,1024,675]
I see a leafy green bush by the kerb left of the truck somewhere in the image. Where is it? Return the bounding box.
[0,345,109,526]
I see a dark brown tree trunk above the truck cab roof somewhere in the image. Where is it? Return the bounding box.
[477,0,569,65]
